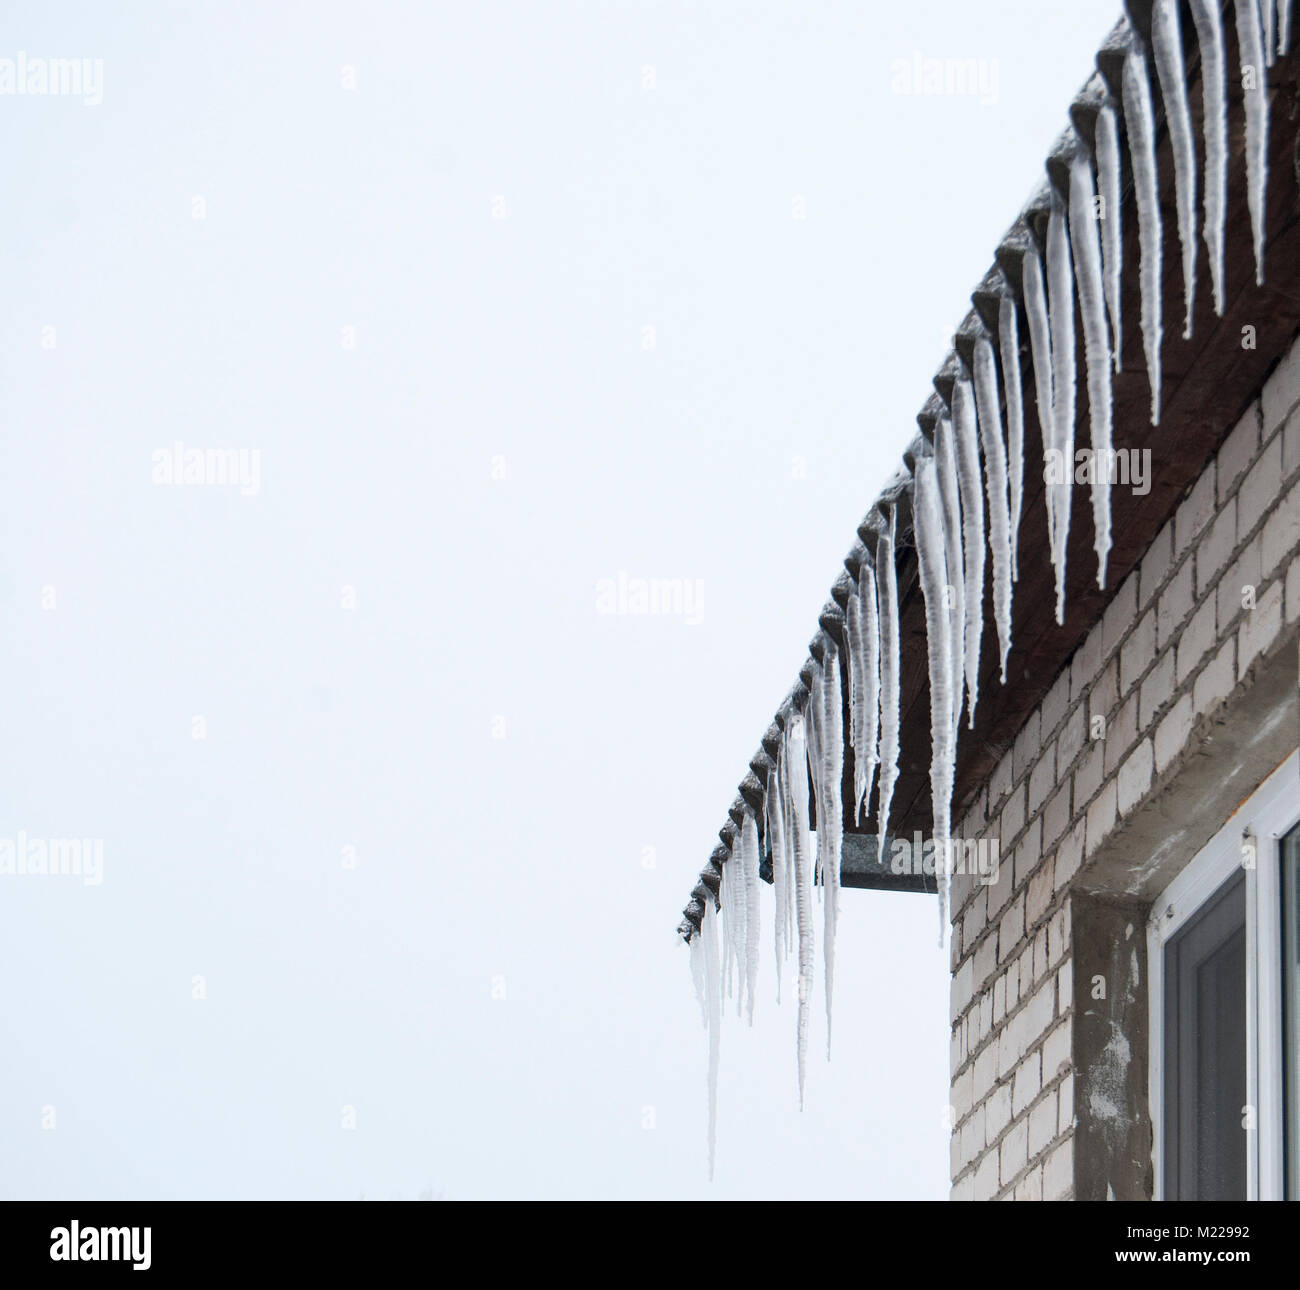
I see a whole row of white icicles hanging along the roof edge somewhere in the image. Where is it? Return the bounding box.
[679,0,1291,1177]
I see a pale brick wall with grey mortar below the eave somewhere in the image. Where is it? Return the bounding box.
[952,330,1300,1200]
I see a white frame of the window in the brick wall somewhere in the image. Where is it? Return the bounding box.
[1147,752,1300,1200]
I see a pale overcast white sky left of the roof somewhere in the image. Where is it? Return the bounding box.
[0,0,1119,1199]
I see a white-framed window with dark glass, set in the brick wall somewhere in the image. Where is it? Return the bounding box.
[1148,754,1300,1200]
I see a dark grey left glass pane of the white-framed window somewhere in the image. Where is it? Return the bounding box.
[1165,873,1247,1200]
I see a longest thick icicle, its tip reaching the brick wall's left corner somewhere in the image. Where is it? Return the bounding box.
[913,458,954,945]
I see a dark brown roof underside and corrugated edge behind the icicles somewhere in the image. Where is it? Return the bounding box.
[683,0,1300,935]
